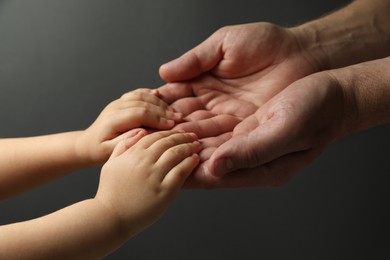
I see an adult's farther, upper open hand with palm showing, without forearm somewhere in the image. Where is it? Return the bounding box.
[160,23,320,187]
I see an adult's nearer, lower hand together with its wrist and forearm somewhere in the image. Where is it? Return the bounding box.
[163,57,390,188]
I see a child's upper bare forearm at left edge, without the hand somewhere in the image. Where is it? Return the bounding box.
[0,132,88,199]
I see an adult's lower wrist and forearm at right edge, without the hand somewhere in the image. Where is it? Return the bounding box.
[330,57,390,135]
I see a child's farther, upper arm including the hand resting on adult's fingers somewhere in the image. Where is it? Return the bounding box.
[0,89,182,200]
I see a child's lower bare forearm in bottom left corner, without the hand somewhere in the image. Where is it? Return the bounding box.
[0,199,134,259]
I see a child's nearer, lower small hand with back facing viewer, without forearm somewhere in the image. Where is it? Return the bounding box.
[96,131,201,233]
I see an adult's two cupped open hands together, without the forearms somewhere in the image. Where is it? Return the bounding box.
[159,23,346,188]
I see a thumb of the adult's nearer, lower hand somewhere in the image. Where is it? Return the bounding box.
[206,113,304,176]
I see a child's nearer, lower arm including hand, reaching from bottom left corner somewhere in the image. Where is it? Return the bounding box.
[0,130,201,259]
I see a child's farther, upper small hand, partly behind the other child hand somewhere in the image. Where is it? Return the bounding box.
[77,89,183,164]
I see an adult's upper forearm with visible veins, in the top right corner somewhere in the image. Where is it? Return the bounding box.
[292,0,390,69]
